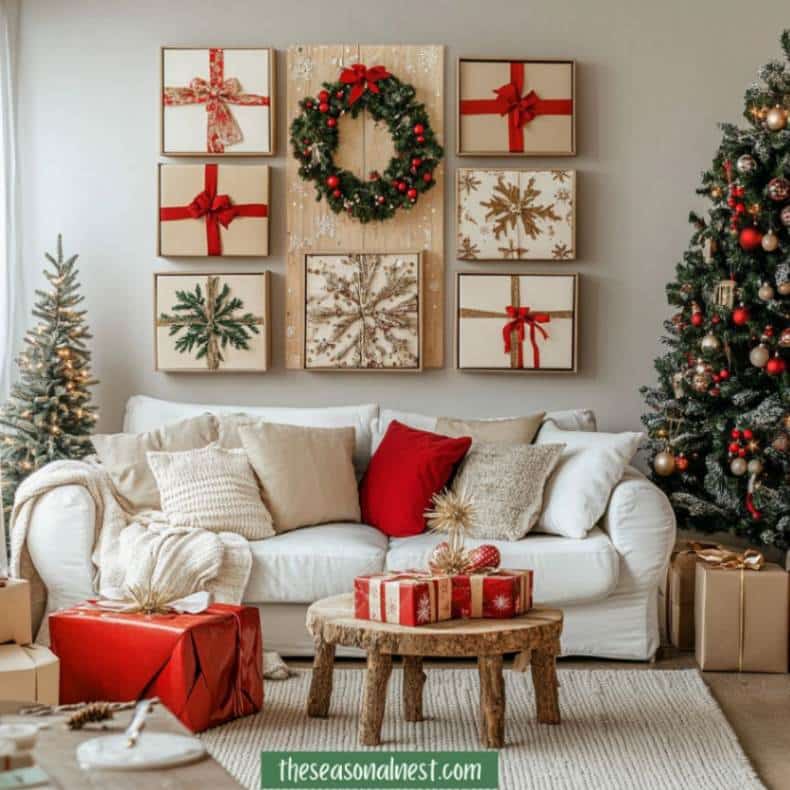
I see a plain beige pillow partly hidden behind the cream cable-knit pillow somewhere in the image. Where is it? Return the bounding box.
[91,414,217,510]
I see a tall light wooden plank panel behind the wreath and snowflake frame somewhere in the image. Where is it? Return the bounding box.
[285,44,444,369]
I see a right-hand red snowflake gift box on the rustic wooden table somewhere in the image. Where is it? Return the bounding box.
[452,569,533,619]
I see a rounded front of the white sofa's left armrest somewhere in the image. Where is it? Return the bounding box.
[27,485,96,613]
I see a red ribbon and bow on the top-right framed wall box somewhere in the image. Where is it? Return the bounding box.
[461,61,573,153]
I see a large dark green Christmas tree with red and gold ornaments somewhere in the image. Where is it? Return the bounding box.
[642,30,790,549]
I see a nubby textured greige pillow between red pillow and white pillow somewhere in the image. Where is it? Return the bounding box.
[454,442,565,540]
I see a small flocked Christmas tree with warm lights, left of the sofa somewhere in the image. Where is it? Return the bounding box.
[0,237,96,523]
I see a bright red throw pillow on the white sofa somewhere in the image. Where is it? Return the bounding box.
[359,420,472,538]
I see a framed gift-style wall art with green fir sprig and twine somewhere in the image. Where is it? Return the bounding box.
[154,272,271,373]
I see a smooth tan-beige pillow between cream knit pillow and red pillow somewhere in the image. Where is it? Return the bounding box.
[238,422,360,532]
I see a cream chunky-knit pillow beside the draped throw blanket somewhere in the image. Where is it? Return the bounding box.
[148,444,274,540]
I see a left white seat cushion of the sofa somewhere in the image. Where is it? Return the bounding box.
[244,524,388,604]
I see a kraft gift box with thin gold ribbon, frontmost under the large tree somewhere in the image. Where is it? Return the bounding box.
[694,562,788,672]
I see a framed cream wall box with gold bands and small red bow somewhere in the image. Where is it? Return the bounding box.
[455,272,579,373]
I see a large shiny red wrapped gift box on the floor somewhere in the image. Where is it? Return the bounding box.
[49,604,263,732]
